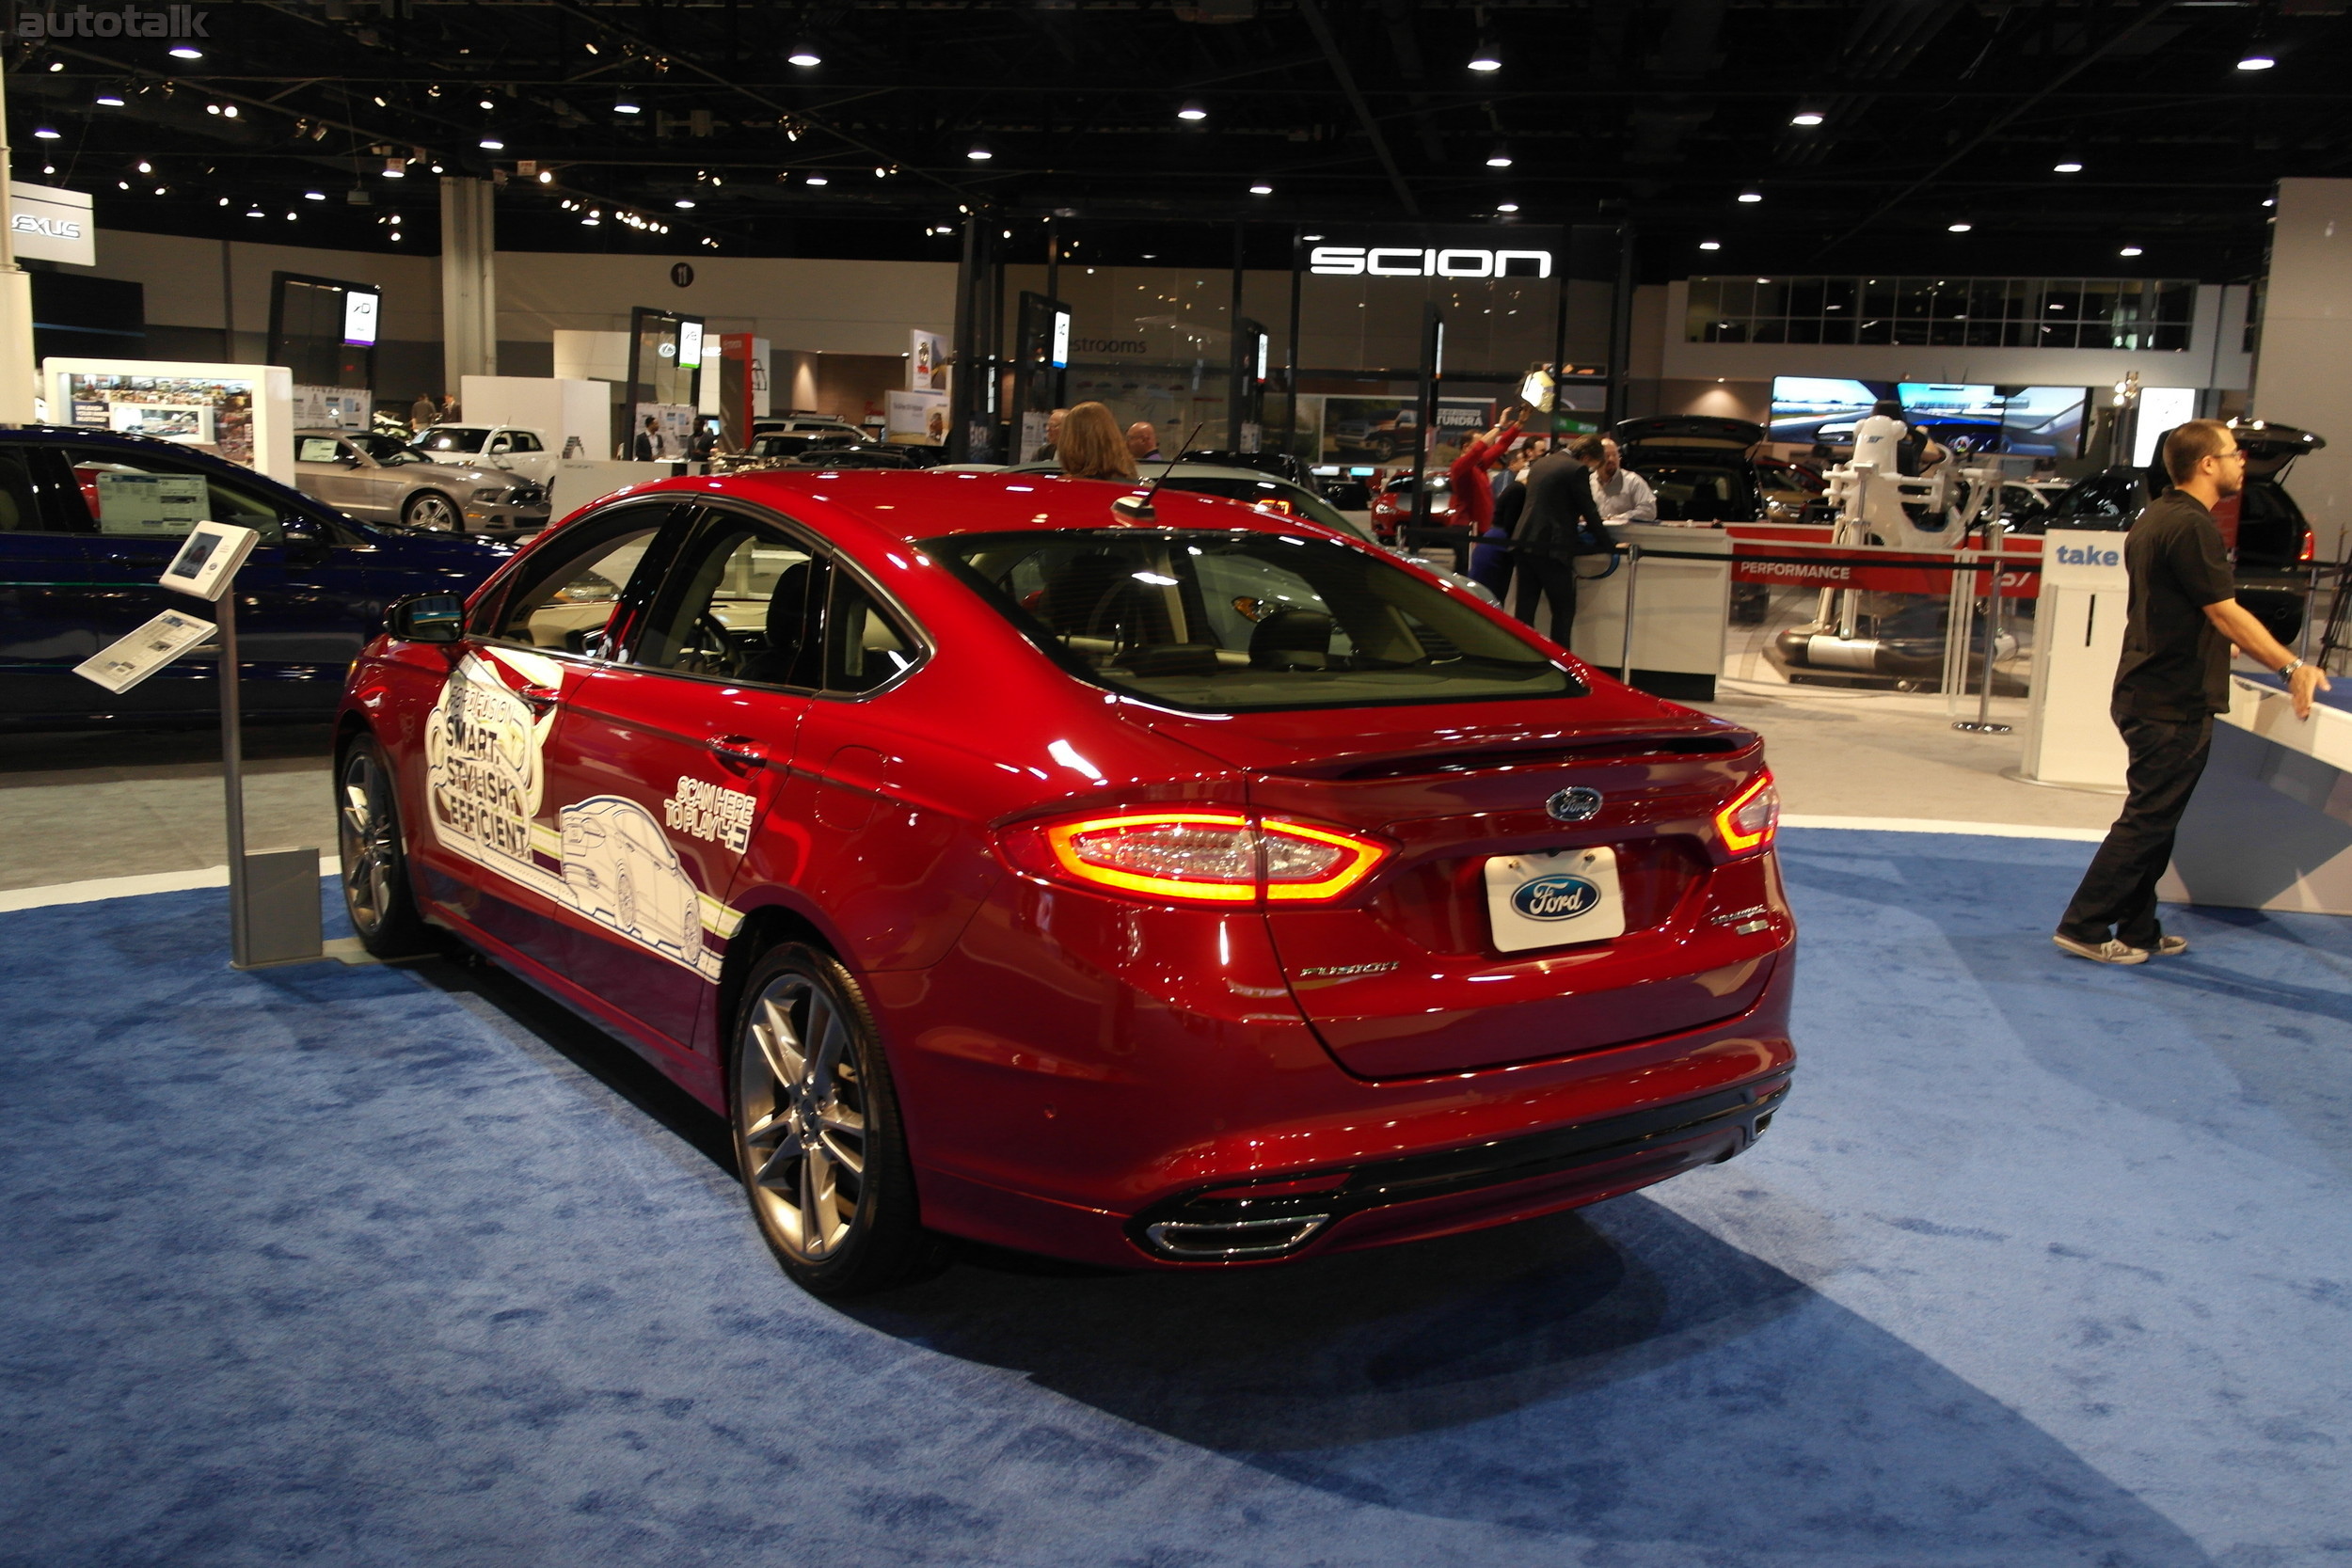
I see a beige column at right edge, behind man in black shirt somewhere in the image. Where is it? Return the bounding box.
[2239,179,2352,560]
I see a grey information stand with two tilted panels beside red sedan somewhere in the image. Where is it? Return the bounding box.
[75,521,325,969]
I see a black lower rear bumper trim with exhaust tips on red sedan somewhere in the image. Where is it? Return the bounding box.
[1127,1072,1790,1265]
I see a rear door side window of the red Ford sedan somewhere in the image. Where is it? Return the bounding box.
[630,508,833,687]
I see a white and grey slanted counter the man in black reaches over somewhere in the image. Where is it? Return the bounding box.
[2157,674,2352,914]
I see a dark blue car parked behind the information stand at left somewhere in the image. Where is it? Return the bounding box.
[0,425,511,729]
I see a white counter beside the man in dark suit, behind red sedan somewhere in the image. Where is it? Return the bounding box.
[1571,522,1731,703]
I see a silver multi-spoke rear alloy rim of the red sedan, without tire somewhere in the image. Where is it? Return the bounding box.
[737,974,868,1262]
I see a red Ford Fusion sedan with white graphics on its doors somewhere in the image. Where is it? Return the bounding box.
[337,470,1795,1295]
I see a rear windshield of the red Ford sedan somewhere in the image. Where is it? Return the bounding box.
[925,529,1585,712]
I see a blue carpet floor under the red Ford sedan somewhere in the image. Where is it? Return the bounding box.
[0,832,2352,1568]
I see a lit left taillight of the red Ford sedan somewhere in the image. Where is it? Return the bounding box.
[1002,811,1388,905]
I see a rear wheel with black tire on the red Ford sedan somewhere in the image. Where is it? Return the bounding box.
[727,942,936,1298]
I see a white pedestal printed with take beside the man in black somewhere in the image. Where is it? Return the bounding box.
[2016,529,2131,795]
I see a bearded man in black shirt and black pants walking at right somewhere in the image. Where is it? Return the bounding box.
[2051,419,2328,964]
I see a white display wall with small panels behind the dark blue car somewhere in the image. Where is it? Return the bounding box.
[40,359,294,484]
